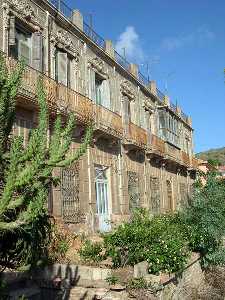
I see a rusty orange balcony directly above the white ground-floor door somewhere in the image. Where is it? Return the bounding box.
[95,105,123,138]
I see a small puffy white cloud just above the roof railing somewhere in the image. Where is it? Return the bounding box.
[115,26,145,63]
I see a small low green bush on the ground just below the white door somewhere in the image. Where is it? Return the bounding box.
[79,240,104,263]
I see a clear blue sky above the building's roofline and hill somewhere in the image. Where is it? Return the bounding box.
[66,0,225,152]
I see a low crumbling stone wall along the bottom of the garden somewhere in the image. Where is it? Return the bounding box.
[1,254,204,300]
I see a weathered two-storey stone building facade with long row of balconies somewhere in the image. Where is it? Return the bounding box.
[0,0,196,231]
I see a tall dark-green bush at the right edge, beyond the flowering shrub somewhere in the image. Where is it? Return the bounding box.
[181,172,225,261]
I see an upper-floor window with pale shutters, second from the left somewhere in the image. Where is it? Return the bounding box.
[55,49,73,87]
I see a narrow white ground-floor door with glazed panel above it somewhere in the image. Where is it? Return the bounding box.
[95,166,111,232]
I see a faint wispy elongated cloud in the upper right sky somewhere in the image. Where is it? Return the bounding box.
[161,26,215,51]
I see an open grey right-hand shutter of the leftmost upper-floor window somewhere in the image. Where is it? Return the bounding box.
[32,32,43,72]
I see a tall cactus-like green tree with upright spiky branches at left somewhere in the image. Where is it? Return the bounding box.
[0,57,92,267]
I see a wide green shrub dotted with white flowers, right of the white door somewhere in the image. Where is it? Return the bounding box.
[104,212,189,274]
